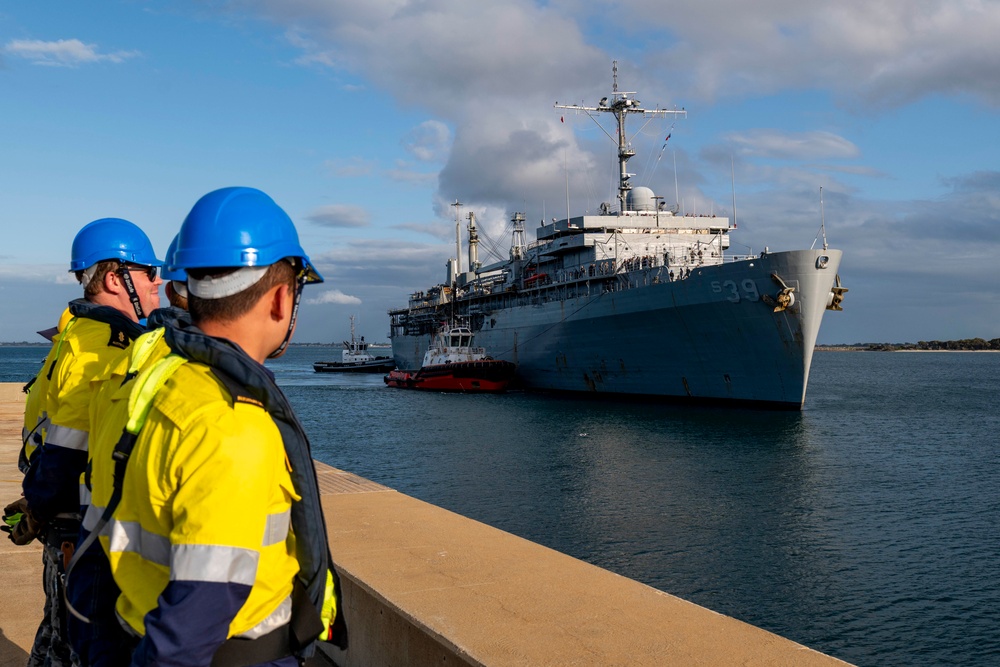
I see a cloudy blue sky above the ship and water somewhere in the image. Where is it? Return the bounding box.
[0,0,1000,344]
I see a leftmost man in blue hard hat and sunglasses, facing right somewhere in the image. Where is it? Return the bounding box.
[5,218,162,666]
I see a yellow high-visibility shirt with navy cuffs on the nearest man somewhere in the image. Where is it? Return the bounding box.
[108,362,299,664]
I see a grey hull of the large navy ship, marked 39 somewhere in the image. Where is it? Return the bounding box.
[392,250,841,409]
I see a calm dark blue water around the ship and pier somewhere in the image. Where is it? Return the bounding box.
[0,347,1000,665]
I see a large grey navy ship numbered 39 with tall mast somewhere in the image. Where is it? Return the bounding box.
[389,66,847,410]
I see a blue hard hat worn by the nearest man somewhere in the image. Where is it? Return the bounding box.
[173,187,323,283]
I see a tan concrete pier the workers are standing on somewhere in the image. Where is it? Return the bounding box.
[0,384,846,667]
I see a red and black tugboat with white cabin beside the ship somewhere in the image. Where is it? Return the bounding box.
[383,326,516,393]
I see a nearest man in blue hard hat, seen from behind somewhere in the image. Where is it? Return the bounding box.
[93,187,346,667]
